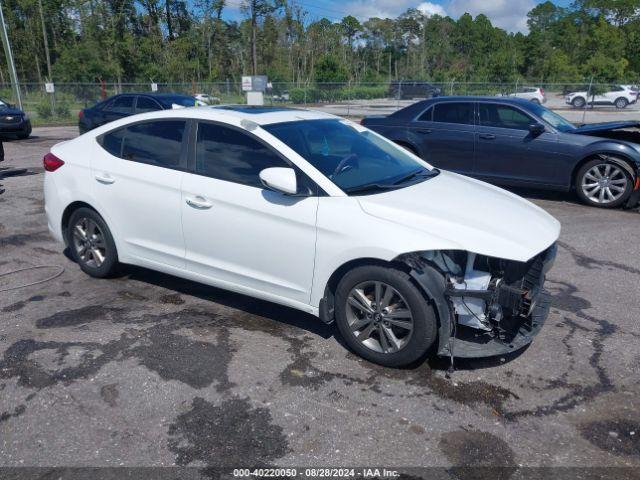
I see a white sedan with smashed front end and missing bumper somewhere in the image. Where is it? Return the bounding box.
[44,106,560,366]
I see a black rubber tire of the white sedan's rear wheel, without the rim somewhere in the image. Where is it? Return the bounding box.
[67,207,119,278]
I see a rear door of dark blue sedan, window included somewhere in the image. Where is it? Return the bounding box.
[412,102,475,174]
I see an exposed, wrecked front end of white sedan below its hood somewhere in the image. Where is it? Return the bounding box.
[396,243,557,358]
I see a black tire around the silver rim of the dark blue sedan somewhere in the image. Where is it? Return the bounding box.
[574,158,633,208]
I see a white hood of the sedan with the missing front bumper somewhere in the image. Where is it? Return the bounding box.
[358,172,560,262]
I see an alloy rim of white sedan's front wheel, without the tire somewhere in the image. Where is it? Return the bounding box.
[347,281,413,353]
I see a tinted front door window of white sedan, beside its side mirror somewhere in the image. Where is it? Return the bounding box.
[196,123,289,188]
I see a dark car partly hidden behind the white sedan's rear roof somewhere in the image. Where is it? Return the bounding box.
[78,93,198,134]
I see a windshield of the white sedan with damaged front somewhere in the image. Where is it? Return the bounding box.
[263,119,438,194]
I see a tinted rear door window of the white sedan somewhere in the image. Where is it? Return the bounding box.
[102,120,186,168]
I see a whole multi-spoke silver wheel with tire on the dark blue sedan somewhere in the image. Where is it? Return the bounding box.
[576,159,633,208]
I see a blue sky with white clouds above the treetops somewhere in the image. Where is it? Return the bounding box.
[222,0,571,32]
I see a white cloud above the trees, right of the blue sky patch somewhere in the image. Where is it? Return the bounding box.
[447,0,536,32]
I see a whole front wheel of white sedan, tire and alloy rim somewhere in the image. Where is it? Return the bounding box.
[336,266,437,367]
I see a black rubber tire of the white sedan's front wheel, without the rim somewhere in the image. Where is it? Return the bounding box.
[336,265,437,367]
